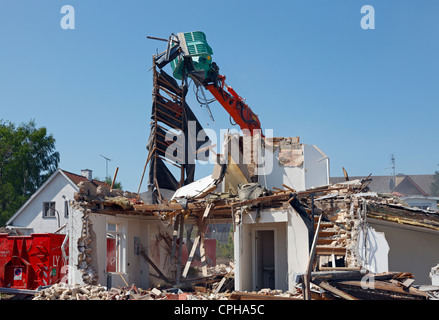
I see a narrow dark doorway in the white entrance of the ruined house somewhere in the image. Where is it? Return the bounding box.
[255,230,276,290]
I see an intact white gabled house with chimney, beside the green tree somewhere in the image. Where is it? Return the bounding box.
[6,169,105,235]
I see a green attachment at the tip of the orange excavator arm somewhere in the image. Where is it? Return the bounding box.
[171,31,213,80]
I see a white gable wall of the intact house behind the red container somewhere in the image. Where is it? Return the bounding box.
[11,174,76,234]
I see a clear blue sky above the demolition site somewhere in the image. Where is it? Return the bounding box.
[0,0,439,191]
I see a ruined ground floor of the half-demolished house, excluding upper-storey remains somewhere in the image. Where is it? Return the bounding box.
[63,132,438,300]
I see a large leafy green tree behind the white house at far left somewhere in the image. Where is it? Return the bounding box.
[0,120,59,226]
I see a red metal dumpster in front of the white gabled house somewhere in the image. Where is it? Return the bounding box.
[0,233,65,290]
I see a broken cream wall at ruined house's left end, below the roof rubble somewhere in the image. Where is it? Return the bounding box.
[69,209,179,288]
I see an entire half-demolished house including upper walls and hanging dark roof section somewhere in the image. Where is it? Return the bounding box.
[55,52,439,300]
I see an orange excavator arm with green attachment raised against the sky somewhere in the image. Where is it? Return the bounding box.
[148,31,262,135]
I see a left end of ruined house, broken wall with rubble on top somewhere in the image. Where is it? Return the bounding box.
[67,184,179,288]
